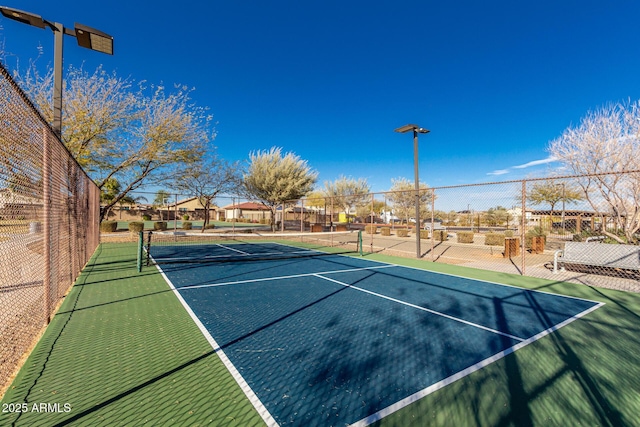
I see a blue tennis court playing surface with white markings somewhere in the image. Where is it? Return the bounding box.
[152,244,601,426]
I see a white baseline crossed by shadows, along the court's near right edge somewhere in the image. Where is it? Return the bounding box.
[350,302,604,427]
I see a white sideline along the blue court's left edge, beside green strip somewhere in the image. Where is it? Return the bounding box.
[156,265,279,427]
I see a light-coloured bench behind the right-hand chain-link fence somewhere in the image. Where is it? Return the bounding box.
[553,242,640,273]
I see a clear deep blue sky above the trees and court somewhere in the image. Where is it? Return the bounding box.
[0,0,640,191]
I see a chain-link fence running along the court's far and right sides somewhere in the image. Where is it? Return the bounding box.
[106,171,640,292]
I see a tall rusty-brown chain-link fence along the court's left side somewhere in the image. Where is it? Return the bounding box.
[0,64,100,390]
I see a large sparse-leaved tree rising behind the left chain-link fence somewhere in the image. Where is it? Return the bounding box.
[18,67,215,224]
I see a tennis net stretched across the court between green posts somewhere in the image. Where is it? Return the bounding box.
[139,230,362,265]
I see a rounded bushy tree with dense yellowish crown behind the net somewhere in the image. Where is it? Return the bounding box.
[244,147,318,230]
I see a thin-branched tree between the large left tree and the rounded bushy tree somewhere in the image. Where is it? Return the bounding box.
[173,155,242,232]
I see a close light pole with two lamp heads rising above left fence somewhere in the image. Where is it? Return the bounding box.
[0,6,113,138]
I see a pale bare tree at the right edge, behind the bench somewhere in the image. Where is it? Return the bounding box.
[548,101,640,243]
